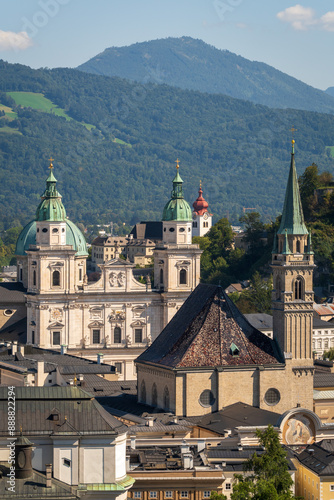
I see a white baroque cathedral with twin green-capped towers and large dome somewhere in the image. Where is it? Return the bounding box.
[16,162,201,380]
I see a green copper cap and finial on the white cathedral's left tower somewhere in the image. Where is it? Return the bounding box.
[36,158,66,221]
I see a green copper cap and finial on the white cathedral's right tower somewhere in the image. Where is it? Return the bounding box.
[162,161,192,222]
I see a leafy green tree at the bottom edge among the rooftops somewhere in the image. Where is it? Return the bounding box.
[231,425,295,500]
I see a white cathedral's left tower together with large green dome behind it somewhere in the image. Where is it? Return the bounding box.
[15,160,88,347]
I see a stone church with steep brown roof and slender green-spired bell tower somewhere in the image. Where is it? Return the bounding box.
[136,141,319,425]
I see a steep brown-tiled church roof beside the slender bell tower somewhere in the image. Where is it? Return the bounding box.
[137,284,284,368]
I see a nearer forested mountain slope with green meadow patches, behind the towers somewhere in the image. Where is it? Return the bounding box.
[0,62,334,226]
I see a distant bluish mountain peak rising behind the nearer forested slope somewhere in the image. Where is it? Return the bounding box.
[77,37,334,113]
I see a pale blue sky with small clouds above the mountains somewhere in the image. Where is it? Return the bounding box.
[0,0,334,90]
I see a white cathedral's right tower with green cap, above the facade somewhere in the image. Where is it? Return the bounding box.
[154,160,202,300]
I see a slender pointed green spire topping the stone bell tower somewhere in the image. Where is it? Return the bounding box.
[277,139,308,235]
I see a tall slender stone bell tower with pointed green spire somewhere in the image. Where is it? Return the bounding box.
[271,140,315,368]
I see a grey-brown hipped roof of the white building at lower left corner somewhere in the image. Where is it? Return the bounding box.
[0,387,127,436]
